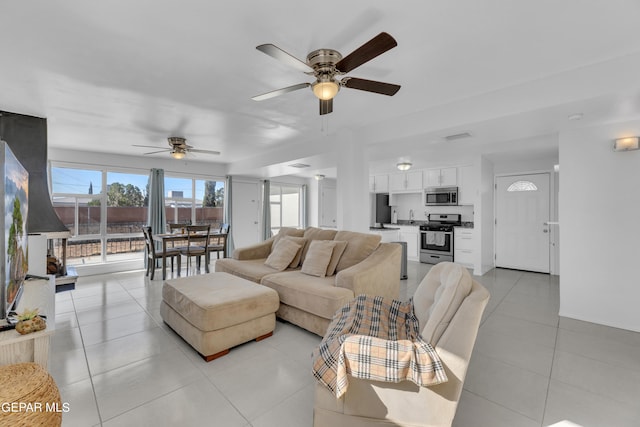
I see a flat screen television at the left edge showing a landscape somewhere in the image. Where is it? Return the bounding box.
[0,141,29,319]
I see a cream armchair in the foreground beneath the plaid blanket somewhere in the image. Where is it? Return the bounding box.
[313,262,489,427]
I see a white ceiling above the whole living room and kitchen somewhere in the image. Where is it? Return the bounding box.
[0,0,640,176]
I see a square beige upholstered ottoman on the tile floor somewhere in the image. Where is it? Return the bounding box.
[160,273,280,362]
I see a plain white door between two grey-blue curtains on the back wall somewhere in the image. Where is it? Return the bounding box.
[231,181,262,248]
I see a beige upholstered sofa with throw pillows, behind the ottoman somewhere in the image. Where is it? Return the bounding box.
[215,227,401,336]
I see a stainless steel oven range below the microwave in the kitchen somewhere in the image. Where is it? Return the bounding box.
[420,214,461,264]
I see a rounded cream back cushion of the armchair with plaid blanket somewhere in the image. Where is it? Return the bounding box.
[413,262,473,346]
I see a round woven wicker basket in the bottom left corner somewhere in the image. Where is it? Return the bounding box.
[0,363,62,427]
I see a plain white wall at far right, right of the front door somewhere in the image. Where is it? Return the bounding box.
[559,121,640,331]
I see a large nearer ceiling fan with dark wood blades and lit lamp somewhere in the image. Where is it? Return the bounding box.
[251,32,400,115]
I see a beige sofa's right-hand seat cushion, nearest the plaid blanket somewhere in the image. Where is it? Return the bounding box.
[260,270,354,319]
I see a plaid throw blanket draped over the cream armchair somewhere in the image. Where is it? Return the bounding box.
[313,295,447,398]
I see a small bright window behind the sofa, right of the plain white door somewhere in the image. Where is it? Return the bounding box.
[269,182,302,234]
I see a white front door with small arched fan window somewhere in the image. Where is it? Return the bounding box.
[496,173,550,273]
